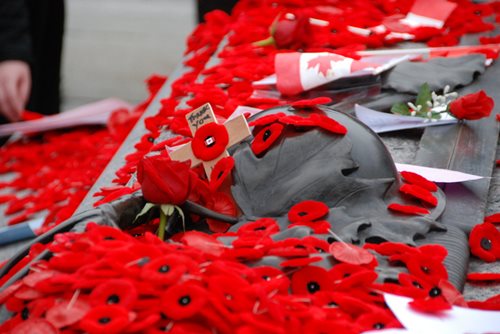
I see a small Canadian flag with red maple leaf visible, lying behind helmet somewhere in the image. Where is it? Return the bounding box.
[274,52,380,95]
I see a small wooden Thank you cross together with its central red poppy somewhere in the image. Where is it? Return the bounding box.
[170,103,251,178]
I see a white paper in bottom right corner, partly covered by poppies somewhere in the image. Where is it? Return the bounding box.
[384,294,500,334]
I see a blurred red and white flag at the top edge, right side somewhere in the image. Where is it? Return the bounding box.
[401,0,457,29]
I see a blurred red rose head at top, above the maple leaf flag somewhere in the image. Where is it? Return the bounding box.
[273,14,311,49]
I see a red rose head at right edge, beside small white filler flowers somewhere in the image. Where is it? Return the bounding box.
[450,90,495,120]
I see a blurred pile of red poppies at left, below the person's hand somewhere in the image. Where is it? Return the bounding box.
[0,76,165,231]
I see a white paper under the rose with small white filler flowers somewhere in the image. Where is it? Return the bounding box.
[354,104,457,133]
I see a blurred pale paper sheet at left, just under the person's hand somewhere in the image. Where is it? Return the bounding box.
[0,98,132,137]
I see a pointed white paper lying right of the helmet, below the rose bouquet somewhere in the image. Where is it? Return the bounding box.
[396,163,484,183]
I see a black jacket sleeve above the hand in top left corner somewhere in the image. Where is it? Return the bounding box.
[0,0,32,62]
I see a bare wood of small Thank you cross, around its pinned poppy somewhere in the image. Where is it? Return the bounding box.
[170,103,251,178]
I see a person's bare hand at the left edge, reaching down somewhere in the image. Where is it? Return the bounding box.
[0,60,31,122]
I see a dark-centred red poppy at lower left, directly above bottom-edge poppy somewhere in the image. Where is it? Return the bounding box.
[90,278,137,308]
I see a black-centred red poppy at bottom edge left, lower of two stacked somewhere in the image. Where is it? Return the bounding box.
[79,305,130,334]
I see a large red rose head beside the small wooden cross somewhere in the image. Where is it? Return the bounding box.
[137,156,191,205]
